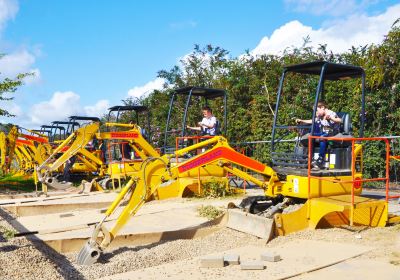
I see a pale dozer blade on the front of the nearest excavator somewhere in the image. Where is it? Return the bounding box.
[226,209,275,241]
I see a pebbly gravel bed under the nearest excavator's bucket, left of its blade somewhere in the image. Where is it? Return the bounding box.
[0,206,265,279]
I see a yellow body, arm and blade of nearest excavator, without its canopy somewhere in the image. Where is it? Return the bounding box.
[78,136,388,263]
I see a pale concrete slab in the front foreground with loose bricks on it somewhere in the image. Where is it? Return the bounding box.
[102,240,372,280]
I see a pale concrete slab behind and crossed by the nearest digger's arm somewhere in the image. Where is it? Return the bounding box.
[8,199,238,252]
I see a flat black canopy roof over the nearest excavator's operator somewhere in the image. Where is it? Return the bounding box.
[284,61,364,80]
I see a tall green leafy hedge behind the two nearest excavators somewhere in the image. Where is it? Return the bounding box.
[121,19,400,180]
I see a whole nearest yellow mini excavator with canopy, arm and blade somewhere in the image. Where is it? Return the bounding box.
[77,61,396,265]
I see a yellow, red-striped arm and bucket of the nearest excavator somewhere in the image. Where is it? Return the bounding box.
[77,136,280,265]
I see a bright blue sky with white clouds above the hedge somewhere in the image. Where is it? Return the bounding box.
[0,0,400,127]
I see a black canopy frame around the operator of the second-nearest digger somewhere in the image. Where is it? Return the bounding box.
[162,86,228,153]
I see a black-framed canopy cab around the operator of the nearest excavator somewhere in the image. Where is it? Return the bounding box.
[271,61,365,176]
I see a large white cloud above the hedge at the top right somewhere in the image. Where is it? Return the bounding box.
[251,4,400,55]
